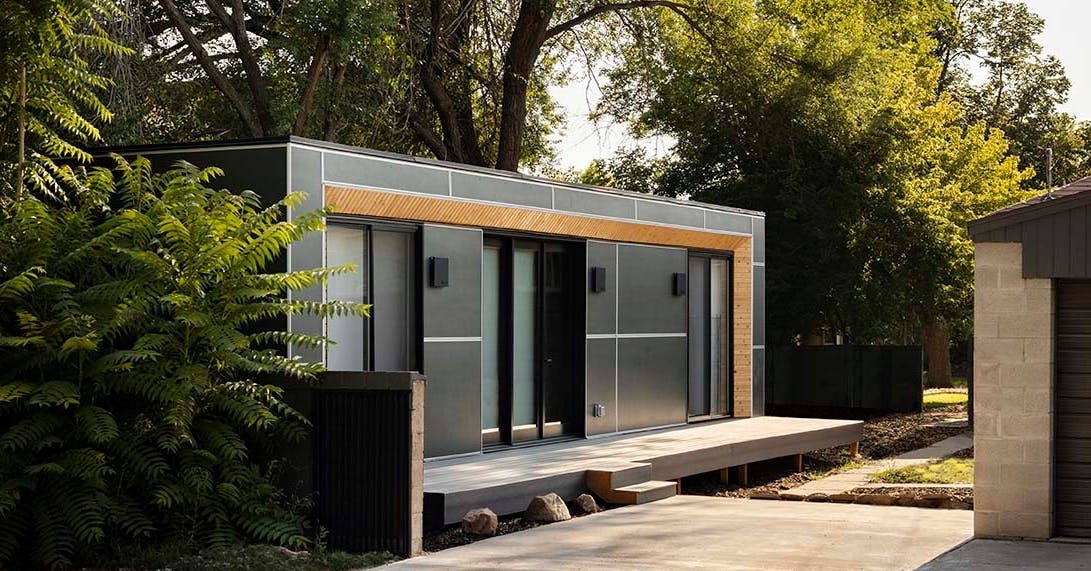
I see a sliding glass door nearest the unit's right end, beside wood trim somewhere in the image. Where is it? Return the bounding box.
[688,254,731,419]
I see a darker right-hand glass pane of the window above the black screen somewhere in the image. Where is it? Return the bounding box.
[371,230,416,371]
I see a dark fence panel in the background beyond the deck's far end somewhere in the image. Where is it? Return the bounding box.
[766,345,924,414]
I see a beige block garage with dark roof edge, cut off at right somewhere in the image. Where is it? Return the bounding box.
[970,177,1091,538]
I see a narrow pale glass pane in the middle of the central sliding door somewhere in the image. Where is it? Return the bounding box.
[512,249,538,427]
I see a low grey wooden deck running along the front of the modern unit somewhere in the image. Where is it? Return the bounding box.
[424,416,863,528]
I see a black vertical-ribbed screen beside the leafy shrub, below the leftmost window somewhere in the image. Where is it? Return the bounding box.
[313,391,411,555]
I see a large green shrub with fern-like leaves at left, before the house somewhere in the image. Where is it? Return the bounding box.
[0,158,368,568]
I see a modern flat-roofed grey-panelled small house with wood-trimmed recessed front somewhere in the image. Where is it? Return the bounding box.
[102,138,765,459]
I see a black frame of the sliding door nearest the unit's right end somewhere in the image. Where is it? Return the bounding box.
[685,250,735,423]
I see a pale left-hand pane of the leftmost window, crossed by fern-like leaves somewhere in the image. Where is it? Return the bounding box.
[326,224,368,371]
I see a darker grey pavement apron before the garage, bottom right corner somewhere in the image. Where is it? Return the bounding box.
[921,539,1091,571]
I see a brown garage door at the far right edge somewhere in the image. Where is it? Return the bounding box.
[1053,281,1091,537]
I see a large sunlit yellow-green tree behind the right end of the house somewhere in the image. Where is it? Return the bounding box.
[604,0,1031,386]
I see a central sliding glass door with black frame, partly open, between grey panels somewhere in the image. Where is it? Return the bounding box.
[481,237,583,444]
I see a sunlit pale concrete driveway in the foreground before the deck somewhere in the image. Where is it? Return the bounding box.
[394,496,973,570]
